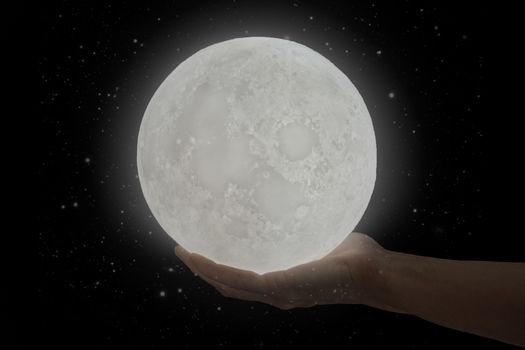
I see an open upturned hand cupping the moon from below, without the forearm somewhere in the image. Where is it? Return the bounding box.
[175,233,390,309]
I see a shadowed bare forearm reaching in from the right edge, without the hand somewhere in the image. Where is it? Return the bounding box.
[369,252,525,346]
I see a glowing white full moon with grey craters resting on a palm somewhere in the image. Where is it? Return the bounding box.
[137,37,376,273]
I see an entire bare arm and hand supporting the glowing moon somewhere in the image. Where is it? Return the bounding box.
[175,233,525,347]
